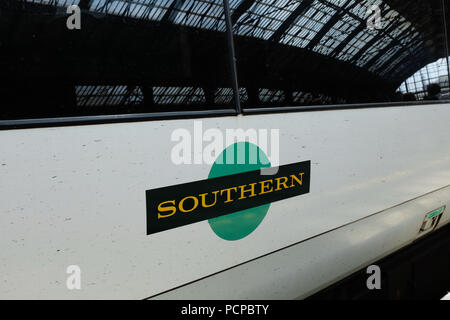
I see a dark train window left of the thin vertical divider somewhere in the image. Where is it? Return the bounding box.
[0,0,234,120]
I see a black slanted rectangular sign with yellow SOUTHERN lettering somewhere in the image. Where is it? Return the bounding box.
[146,161,311,235]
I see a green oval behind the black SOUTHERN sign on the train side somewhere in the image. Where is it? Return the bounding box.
[208,142,270,241]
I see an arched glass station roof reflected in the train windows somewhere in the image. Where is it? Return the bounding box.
[26,0,436,81]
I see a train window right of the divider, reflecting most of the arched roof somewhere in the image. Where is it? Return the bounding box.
[230,0,449,109]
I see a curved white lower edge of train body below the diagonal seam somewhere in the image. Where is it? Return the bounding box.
[154,187,450,300]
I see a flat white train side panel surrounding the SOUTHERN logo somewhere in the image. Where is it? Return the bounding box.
[0,105,450,299]
